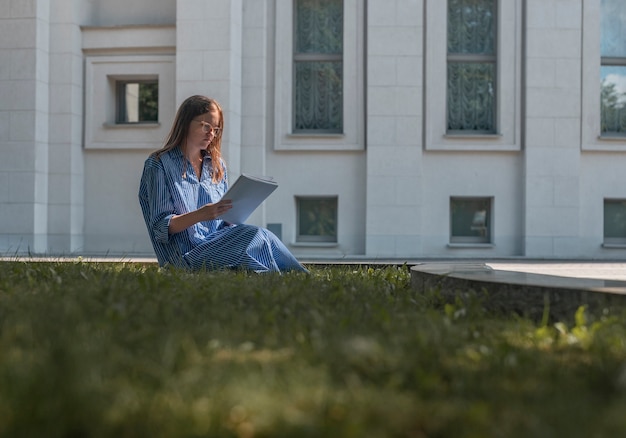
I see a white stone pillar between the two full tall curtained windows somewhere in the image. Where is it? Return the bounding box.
[366,0,424,257]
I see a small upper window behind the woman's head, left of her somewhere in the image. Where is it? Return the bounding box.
[115,80,159,124]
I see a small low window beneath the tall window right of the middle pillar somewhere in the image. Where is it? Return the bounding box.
[450,197,493,244]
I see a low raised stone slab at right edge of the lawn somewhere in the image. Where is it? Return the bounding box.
[411,260,626,320]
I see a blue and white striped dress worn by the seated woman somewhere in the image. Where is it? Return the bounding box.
[139,148,307,272]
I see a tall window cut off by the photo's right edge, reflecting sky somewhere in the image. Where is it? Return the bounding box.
[600,0,626,136]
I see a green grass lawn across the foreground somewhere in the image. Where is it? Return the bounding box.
[0,261,626,438]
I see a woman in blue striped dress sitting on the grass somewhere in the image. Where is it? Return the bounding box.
[139,96,306,272]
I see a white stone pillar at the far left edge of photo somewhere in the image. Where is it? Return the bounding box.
[0,0,50,255]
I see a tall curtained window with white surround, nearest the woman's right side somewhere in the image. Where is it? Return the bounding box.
[273,0,366,151]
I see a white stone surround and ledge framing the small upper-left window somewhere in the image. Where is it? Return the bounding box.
[81,25,176,150]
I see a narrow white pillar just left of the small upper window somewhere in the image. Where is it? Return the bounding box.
[48,0,85,254]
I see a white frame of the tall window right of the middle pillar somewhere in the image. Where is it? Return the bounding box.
[423,0,522,151]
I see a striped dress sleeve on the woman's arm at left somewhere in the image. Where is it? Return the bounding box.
[139,156,175,243]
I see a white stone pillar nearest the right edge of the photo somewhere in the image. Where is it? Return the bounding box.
[524,0,582,257]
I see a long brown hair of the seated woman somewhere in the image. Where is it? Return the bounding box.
[154,95,224,183]
